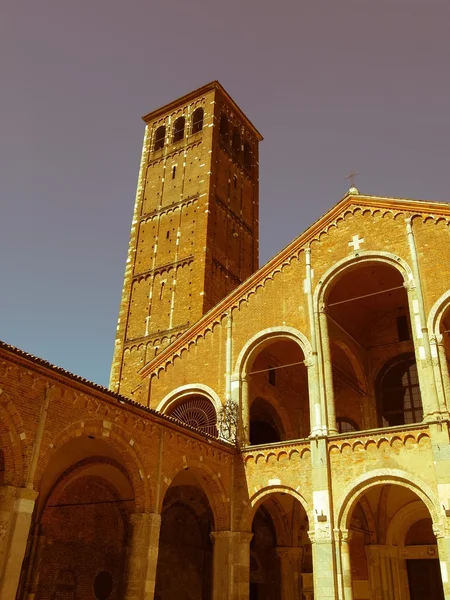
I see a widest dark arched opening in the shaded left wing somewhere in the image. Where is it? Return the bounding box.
[30,456,130,600]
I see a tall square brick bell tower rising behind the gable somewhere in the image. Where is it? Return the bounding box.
[110,81,262,399]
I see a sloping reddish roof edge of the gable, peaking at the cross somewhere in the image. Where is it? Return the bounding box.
[139,193,450,378]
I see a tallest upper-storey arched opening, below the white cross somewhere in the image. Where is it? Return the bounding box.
[325,260,423,429]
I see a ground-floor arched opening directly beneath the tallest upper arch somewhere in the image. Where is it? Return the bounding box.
[347,484,444,600]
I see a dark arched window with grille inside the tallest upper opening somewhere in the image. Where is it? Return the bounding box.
[377,356,423,427]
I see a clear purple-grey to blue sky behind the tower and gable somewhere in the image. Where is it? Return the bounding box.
[0,0,450,385]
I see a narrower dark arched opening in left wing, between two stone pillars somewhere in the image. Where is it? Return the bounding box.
[155,469,214,600]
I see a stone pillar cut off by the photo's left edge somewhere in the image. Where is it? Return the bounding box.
[0,485,38,600]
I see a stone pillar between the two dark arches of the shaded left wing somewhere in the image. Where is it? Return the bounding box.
[125,513,161,600]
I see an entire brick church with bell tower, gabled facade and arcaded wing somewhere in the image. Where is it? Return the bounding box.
[0,82,450,600]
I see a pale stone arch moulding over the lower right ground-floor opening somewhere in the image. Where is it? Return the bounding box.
[336,469,442,529]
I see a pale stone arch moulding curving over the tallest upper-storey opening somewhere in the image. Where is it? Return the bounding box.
[314,250,414,308]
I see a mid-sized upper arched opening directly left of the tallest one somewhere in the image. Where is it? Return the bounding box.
[246,336,310,444]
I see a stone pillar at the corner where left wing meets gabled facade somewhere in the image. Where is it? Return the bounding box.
[211,531,253,600]
